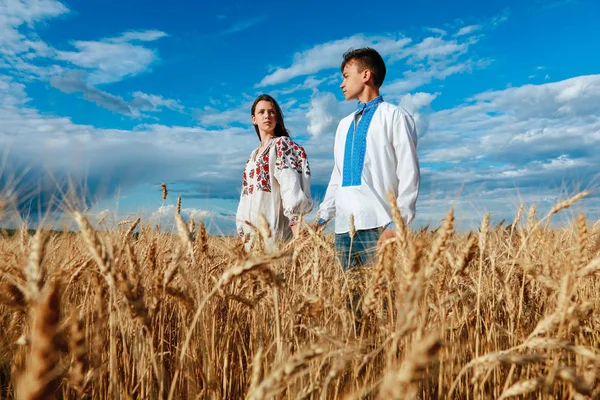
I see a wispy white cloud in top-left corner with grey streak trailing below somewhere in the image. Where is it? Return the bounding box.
[0,5,173,117]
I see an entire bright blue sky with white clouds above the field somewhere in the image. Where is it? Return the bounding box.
[0,0,600,233]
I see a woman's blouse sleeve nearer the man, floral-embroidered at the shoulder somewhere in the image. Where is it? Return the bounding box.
[274,137,313,225]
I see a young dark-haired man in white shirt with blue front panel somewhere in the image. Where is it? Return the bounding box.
[318,48,420,270]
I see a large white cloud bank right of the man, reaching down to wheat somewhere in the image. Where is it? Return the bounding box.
[408,75,600,227]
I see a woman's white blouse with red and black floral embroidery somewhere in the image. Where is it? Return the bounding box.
[236,137,313,248]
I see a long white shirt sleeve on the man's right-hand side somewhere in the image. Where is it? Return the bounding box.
[393,110,421,224]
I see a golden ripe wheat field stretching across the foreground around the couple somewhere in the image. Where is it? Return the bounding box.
[0,193,600,400]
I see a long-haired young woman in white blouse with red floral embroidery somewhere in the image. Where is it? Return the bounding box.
[236,94,313,250]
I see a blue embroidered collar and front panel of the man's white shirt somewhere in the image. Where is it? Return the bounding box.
[342,96,383,186]
